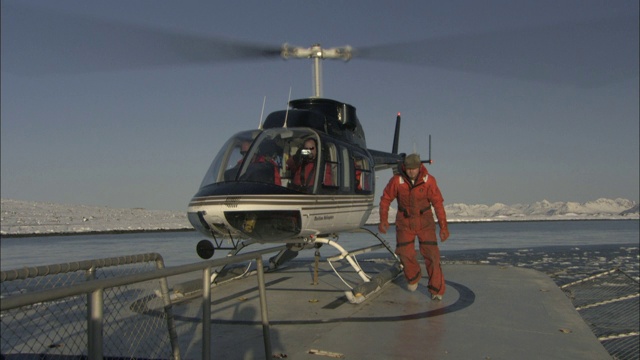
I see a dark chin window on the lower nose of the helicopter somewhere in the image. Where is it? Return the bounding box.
[224,210,302,242]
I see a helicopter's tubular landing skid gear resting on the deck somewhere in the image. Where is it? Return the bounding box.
[198,228,402,304]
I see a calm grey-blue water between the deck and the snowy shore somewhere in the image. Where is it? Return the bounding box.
[0,220,640,270]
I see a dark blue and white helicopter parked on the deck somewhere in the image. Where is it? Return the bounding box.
[188,44,416,300]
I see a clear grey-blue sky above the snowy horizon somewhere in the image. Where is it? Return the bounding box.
[0,0,640,211]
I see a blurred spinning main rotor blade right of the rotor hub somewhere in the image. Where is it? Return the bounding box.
[354,17,638,87]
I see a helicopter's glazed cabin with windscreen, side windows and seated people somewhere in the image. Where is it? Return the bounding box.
[201,128,373,194]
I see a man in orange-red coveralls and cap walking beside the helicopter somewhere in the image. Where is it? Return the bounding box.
[378,154,449,300]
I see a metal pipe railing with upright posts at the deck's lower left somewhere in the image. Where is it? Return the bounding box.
[0,246,285,359]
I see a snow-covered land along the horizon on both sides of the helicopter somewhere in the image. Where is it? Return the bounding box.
[0,199,640,237]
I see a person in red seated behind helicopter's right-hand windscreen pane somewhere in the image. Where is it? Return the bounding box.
[287,138,331,192]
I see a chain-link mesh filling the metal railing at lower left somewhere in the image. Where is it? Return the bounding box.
[0,253,177,359]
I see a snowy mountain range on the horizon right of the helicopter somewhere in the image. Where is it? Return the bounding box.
[367,198,640,223]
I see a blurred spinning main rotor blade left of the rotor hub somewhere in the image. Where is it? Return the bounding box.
[2,4,281,75]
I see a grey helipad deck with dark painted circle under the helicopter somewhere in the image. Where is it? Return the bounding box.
[168,261,611,359]
